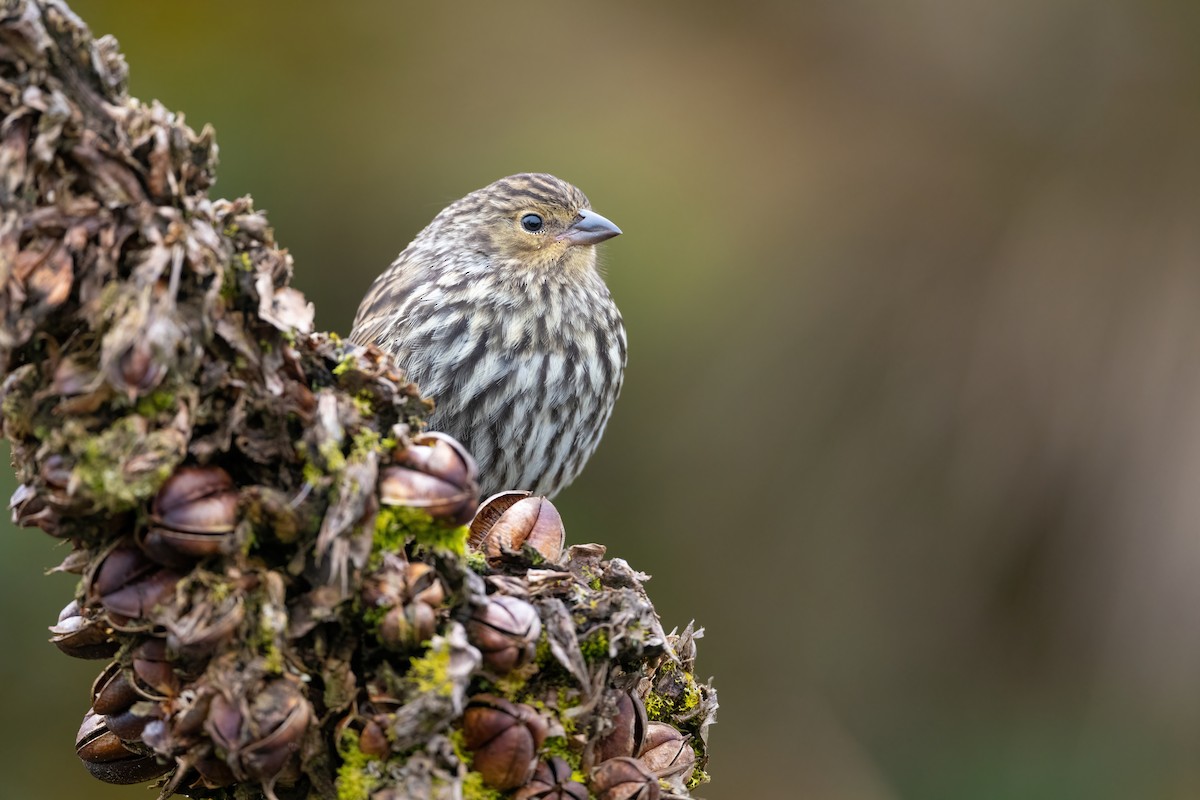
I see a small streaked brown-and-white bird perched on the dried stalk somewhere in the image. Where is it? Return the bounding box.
[349,173,628,498]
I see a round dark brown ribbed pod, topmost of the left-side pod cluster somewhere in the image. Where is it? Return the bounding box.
[138,467,240,569]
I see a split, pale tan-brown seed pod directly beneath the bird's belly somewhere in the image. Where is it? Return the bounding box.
[470,492,566,565]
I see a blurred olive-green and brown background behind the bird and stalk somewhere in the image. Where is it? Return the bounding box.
[0,0,1200,800]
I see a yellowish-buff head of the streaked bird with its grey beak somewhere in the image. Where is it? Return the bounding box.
[446,173,620,273]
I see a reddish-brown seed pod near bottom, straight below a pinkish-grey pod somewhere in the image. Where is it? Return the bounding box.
[462,694,547,789]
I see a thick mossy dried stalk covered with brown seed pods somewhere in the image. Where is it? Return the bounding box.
[0,0,716,800]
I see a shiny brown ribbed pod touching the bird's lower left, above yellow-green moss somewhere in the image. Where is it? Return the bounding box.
[379,433,479,524]
